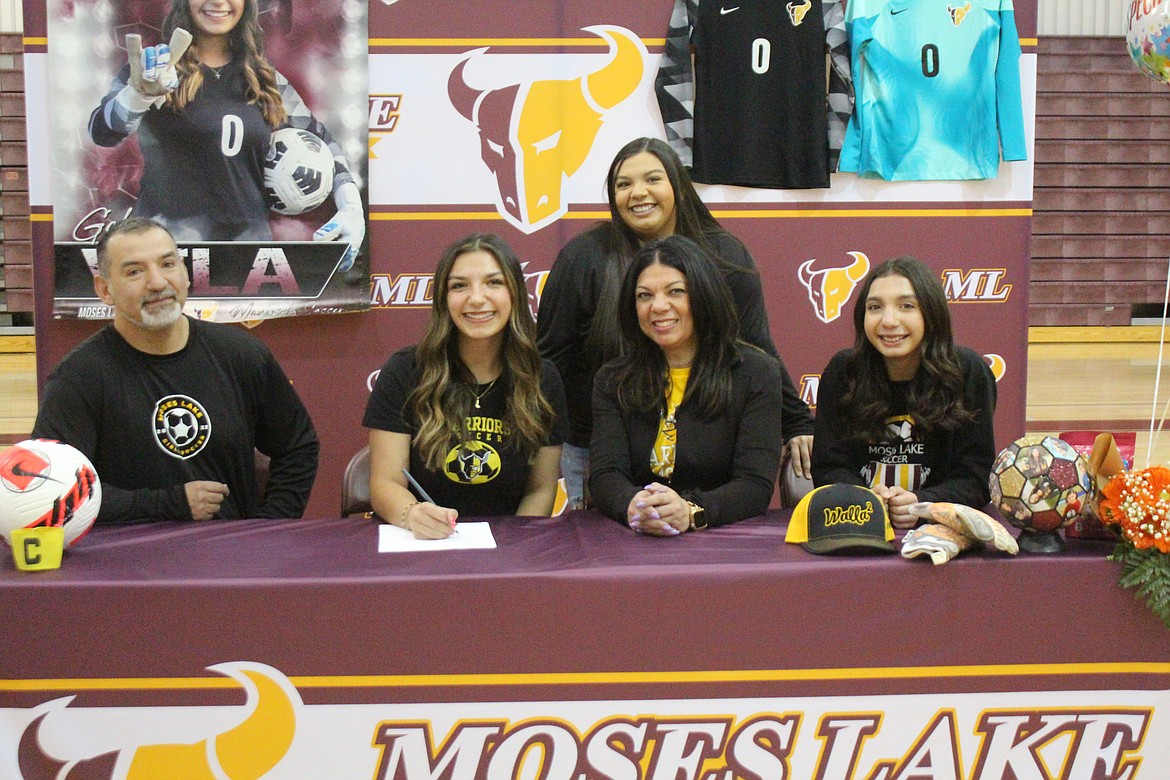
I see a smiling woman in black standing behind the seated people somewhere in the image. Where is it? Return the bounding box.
[537,138,813,508]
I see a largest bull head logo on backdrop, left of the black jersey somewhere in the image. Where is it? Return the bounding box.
[447,26,648,233]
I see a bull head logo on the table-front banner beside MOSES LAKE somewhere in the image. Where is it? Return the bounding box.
[19,663,301,780]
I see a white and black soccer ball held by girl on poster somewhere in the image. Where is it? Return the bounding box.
[264,127,333,215]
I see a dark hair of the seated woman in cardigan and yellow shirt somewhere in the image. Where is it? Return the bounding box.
[614,235,739,417]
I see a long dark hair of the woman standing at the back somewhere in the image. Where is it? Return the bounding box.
[586,138,750,365]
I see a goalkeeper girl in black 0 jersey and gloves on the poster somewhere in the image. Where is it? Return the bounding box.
[89,0,365,261]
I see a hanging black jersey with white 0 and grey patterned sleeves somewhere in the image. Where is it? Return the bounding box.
[656,0,851,188]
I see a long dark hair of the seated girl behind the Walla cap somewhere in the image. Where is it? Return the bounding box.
[840,257,976,441]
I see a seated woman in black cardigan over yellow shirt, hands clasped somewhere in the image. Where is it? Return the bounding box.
[590,236,784,536]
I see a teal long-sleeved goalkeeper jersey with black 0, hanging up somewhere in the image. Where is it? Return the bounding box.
[840,0,1027,181]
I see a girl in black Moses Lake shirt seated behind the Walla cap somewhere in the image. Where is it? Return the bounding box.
[812,257,996,529]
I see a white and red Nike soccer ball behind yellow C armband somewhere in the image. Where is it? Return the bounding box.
[0,439,102,546]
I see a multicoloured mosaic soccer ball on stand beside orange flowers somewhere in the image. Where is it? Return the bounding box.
[990,435,1093,532]
